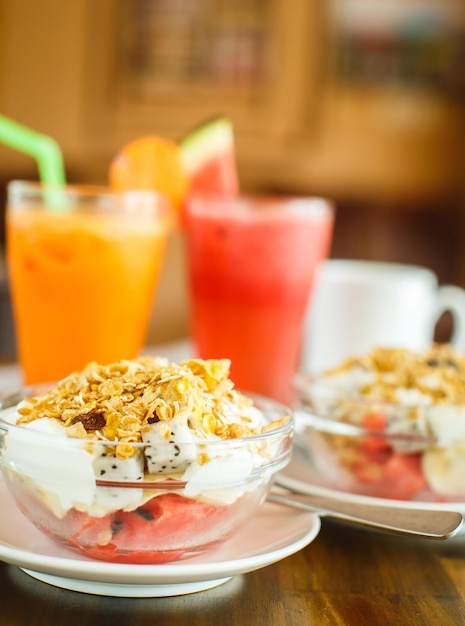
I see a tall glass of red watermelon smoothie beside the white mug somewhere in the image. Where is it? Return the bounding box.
[185,196,334,404]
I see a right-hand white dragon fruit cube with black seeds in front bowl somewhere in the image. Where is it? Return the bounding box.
[142,418,197,474]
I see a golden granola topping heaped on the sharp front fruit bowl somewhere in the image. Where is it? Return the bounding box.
[17,357,276,444]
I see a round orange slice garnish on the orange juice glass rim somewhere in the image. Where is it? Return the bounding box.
[109,135,189,210]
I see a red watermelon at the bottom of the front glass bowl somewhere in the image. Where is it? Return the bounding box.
[13,476,228,564]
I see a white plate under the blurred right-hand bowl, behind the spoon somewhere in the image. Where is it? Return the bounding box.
[277,446,465,516]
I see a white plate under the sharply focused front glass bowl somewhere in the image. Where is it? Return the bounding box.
[0,477,320,597]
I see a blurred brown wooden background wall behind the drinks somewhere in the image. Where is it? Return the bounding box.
[0,0,465,353]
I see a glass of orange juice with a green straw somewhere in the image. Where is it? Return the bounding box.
[6,181,170,384]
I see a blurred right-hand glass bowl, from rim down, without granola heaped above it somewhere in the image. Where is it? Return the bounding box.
[295,374,465,502]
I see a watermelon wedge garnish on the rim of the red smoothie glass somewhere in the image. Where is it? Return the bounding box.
[179,117,239,197]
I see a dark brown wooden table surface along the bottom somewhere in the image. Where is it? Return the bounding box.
[0,512,465,626]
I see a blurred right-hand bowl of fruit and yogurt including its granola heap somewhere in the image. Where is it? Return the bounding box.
[297,344,465,502]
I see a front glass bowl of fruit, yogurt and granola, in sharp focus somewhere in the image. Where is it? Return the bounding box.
[0,357,292,563]
